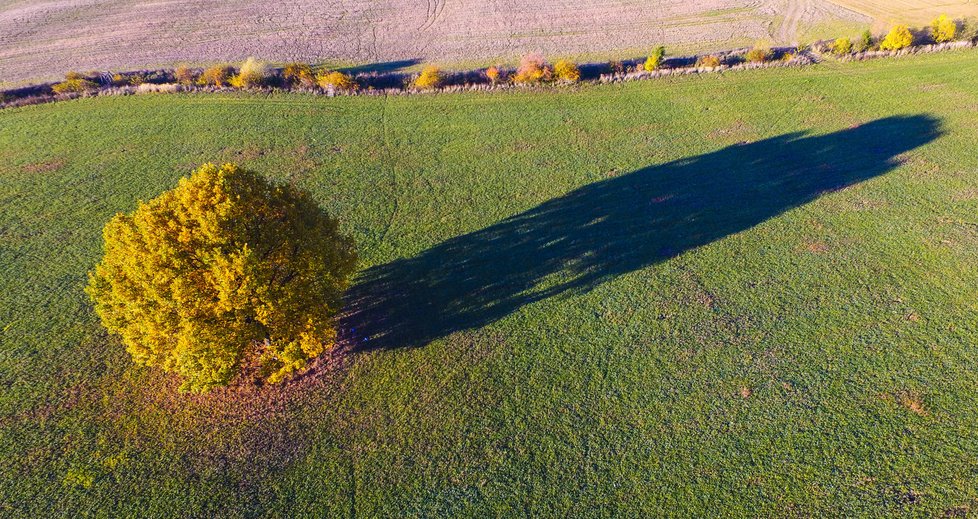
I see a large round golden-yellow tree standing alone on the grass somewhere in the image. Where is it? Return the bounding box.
[86,164,356,392]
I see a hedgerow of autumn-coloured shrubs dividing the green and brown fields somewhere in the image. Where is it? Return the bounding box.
[7,16,978,107]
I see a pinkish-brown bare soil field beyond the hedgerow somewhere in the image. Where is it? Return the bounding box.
[0,0,870,82]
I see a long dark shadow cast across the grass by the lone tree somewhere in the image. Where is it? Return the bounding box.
[343,115,940,349]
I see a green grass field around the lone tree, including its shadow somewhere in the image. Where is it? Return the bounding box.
[0,51,978,517]
